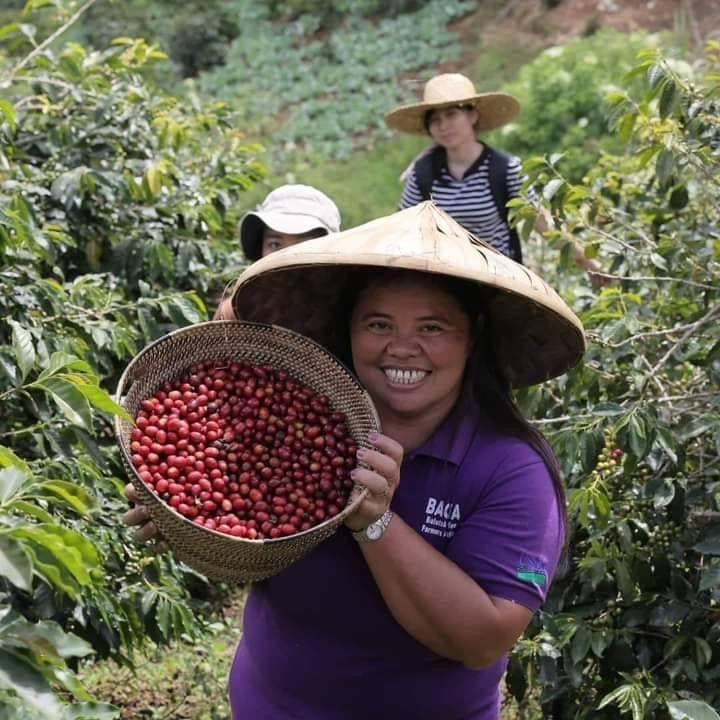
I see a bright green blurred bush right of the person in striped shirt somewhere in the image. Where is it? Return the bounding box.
[496,31,657,182]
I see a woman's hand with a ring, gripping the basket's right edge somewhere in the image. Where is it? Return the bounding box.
[345,433,403,531]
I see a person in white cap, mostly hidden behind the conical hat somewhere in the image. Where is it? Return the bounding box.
[214,185,340,320]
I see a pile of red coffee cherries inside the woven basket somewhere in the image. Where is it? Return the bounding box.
[130,362,357,539]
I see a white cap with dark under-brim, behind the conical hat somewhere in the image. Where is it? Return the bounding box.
[240,185,340,260]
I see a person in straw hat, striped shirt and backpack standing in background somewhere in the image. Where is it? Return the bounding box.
[385,73,603,285]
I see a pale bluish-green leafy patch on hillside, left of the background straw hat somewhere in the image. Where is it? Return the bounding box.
[200,0,472,164]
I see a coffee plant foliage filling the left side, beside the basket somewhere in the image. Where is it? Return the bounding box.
[0,0,262,720]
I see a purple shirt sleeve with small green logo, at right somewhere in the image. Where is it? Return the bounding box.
[447,442,563,611]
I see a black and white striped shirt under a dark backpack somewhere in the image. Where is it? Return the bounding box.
[400,147,524,256]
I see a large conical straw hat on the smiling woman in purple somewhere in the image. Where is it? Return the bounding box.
[232,201,585,387]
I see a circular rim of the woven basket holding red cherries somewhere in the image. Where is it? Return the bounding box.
[113,320,381,547]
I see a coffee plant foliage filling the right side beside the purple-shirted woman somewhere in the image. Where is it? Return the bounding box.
[509,43,720,720]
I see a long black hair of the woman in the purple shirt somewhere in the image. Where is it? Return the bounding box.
[336,268,567,537]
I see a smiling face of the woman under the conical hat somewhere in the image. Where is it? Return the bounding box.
[350,276,471,423]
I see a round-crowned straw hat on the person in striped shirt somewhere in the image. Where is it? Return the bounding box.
[385,73,520,135]
